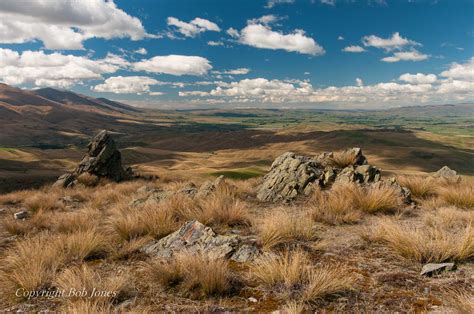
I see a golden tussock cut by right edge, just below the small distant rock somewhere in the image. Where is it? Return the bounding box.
[437,181,474,209]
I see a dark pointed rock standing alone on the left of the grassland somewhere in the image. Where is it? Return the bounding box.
[54,130,131,188]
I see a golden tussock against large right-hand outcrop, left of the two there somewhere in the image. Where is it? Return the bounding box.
[310,184,362,225]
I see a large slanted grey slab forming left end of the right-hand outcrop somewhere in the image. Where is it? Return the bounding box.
[257,152,324,202]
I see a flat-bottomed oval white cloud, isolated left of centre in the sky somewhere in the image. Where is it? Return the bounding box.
[133,55,212,76]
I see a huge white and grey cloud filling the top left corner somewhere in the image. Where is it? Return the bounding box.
[0,0,153,50]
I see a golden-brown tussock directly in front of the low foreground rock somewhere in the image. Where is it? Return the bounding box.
[143,254,231,299]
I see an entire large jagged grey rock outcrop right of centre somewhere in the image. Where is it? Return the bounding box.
[257,148,380,202]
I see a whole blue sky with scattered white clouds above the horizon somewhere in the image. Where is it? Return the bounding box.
[0,0,474,109]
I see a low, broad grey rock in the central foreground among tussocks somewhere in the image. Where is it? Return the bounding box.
[142,221,259,262]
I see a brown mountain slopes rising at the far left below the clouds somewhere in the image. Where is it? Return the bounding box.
[0,83,141,147]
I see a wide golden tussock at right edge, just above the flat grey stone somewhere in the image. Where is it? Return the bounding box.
[373,211,474,263]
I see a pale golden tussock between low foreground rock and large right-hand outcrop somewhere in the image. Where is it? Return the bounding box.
[257,208,316,249]
